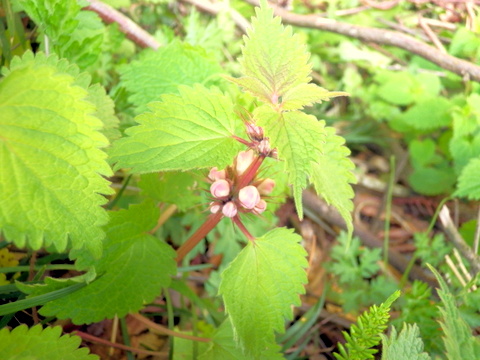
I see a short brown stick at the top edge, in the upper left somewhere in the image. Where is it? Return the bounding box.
[84,0,160,50]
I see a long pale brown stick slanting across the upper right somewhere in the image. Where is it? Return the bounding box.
[245,0,480,82]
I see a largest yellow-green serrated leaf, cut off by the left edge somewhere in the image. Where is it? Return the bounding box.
[0,53,113,256]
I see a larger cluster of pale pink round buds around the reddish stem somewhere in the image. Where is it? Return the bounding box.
[208,150,275,218]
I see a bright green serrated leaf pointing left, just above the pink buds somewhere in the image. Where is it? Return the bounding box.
[110,85,240,173]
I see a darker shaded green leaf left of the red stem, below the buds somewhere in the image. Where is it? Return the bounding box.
[20,202,176,324]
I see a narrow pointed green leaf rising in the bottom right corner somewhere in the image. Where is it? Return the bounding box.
[428,265,480,360]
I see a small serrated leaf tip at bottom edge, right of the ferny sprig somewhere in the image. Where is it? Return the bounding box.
[380,323,430,360]
